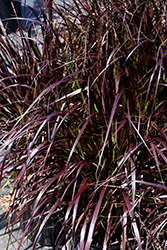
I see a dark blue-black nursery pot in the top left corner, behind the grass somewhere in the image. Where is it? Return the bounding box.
[0,0,21,32]
